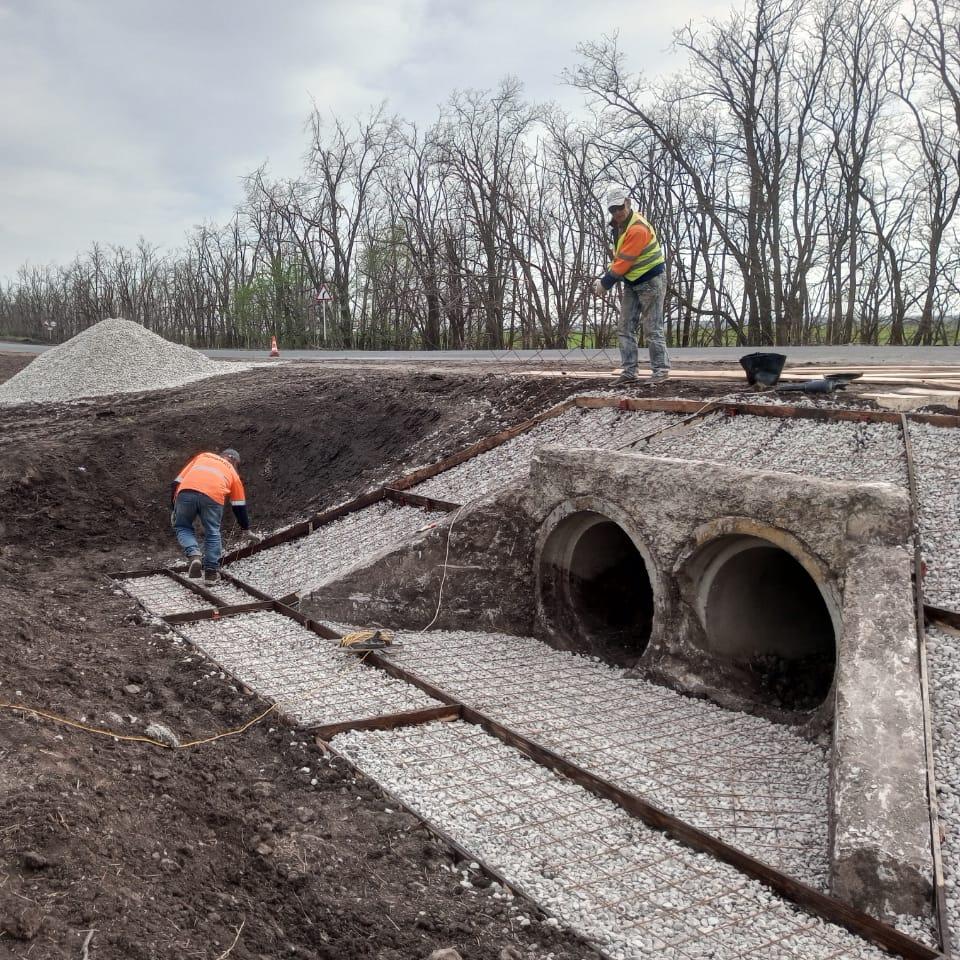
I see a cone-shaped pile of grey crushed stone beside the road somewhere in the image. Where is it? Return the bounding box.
[0,318,250,405]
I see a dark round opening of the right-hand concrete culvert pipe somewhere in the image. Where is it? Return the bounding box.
[688,535,837,710]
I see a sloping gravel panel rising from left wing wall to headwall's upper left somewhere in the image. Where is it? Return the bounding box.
[411,407,681,503]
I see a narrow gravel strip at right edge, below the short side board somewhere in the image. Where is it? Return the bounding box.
[927,627,960,931]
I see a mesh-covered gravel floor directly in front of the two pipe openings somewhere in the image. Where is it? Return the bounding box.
[393,631,830,889]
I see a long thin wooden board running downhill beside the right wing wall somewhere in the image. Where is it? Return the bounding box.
[900,413,951,955]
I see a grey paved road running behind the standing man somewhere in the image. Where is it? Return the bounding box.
[0,340,960,366]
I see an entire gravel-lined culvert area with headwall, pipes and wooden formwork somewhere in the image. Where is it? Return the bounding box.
[110,397,960,960]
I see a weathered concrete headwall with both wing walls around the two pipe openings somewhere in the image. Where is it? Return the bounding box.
[306,448,932,916]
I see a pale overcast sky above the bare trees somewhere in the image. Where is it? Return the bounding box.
[0,0,730,280]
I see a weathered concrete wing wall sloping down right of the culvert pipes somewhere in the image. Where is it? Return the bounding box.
[831,546,933,916]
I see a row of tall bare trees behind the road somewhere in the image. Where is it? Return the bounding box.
[0,0,960,349]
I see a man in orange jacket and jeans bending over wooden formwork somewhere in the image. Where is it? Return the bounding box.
[170,449,258,583]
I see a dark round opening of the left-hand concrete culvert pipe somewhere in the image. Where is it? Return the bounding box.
[538,510,654,666]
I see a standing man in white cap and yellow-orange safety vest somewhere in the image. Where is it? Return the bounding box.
[594,186,670,383]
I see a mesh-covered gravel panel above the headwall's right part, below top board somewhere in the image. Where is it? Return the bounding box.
[645,414,907,486]
